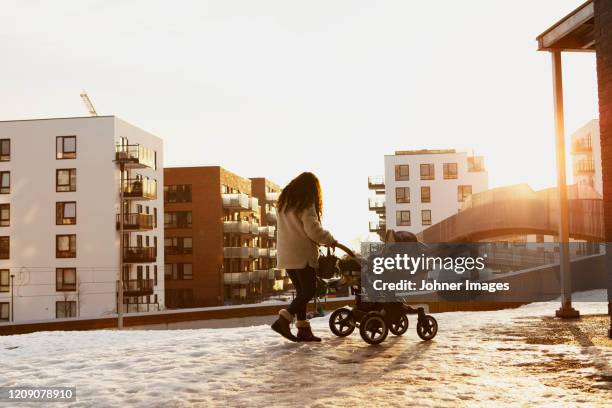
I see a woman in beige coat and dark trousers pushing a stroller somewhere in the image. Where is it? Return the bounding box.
[272,172,336,341]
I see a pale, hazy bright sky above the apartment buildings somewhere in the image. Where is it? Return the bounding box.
[0,0,598,246]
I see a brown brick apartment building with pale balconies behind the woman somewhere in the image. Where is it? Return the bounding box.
[164,166,283,308]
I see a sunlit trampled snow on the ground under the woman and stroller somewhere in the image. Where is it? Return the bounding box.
[0,292,612,407]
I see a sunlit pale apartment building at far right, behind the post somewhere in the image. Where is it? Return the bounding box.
[570,119,603,194]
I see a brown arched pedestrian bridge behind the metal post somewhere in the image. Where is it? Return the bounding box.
[419,184,604,242]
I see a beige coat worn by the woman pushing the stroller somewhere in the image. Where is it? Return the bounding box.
[276,206,335,269]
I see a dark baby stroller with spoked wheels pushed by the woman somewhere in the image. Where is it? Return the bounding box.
[319,233,438,344]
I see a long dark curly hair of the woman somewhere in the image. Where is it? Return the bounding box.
[278,172,323,218]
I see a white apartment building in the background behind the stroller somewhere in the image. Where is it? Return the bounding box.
[368,149,488,235]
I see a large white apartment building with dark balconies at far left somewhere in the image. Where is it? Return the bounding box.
[0,116,164,324]
